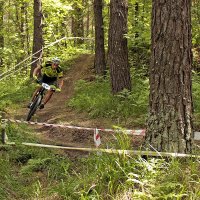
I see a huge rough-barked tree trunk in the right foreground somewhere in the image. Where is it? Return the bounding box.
[146,0,193,153]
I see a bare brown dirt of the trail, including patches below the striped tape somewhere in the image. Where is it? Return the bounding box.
[10,54,142,157]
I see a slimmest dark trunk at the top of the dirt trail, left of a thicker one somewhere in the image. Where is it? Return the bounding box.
[94,0,106,75]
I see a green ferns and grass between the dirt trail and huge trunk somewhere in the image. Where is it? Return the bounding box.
[68,71,148,126]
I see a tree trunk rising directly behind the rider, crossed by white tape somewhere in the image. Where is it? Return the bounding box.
[30,0,43,77]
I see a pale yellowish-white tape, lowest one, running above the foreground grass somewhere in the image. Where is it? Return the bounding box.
[3,142,200,159]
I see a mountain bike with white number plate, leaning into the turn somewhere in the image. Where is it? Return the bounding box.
[26,83,51,121]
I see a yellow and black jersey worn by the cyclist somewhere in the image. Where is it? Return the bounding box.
[42,63,63,78]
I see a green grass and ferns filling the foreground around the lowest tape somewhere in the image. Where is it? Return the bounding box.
[0,124,200,200]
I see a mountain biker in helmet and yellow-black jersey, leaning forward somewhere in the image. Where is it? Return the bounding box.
[28,57,63,109]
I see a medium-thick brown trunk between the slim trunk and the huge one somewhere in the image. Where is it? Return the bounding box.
[108,0,131,94]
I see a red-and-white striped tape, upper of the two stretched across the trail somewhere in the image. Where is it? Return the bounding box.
[2,119,145,136]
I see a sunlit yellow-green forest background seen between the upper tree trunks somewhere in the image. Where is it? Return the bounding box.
[0,0,200,71]
